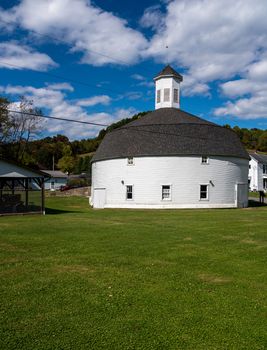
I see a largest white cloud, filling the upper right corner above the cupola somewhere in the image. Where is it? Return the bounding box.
[143,0,267,92]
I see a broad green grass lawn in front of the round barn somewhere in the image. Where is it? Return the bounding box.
[0,197,267,350]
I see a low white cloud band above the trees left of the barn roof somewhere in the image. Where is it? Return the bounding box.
[0,83,136,140]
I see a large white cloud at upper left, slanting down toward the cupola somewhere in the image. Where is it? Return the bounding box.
[3,0,147,66]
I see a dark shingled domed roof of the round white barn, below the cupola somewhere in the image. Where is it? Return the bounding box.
[92,108,249,162]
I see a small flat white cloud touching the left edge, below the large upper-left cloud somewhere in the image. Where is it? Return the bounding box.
[0,41,57,71]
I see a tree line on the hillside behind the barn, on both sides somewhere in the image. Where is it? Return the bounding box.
[0,97,267,176]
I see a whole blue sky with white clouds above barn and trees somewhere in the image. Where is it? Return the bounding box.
[0,0,267,139]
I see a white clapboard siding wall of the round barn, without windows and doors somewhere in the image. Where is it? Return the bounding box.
[91,156,248,208]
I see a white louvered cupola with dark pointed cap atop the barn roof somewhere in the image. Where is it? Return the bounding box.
[154,65,183,109]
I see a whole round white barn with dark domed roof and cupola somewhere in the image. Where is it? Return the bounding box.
[91,66,249,208]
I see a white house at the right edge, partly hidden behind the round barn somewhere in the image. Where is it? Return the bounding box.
[248,153,267,192]
